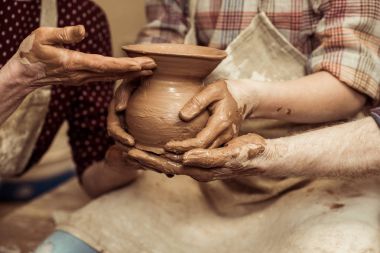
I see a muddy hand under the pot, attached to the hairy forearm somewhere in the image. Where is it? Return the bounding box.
[128,134,266,182]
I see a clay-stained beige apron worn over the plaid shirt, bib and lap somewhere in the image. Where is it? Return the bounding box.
[58,5,380,253]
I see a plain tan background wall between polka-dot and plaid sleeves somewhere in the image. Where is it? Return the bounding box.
[93,0,145,56]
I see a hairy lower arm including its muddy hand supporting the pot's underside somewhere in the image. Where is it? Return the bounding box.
[174,118,380,181]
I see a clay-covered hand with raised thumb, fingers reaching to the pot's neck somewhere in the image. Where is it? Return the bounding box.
[7,25,156,87]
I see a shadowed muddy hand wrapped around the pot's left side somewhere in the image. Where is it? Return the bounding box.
[107,80,137,147]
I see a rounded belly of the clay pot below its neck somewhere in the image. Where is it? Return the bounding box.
[126,75,208,151]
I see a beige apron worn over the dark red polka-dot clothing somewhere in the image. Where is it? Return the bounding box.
[0,0,58,177]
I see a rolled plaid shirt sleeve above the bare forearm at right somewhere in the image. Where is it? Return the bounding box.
[309,0,380,102]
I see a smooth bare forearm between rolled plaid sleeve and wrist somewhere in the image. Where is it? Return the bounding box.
[229,72,365,123]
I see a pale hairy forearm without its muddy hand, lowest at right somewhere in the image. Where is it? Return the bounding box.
[252,117,380,177]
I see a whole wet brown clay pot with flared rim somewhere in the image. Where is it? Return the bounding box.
[123,44,226,154]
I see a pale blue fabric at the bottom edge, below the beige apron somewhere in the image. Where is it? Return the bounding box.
[35,230,98,253]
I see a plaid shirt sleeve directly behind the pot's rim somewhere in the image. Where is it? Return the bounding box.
[137,0,189,43]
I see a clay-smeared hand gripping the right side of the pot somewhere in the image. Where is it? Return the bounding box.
[165,81,256,153]
